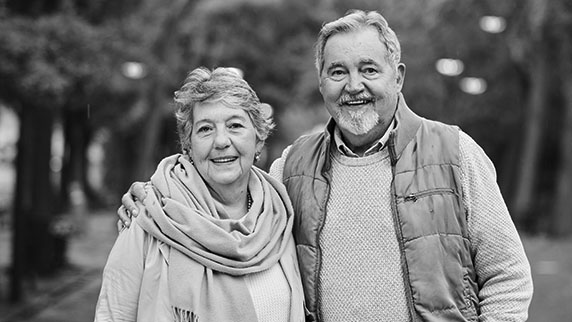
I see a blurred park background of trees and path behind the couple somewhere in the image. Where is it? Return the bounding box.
[0,0,572,321]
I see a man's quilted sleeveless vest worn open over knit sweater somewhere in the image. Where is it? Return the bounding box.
[283,95,478,322]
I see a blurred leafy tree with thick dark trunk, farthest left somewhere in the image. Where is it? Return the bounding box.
[0,1,136,300]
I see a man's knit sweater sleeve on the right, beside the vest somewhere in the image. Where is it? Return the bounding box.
[459,132,533,322]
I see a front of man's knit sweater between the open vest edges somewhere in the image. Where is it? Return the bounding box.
[318,149,409,322]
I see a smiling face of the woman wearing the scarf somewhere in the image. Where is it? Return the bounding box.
[189,102,263,193]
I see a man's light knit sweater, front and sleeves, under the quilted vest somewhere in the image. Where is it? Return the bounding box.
[270,132,532,322]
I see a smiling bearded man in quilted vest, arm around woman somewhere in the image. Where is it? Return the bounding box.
[119,11,533,321]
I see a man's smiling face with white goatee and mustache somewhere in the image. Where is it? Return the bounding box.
[320,27,405,144]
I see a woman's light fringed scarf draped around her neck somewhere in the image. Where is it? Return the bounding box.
[138,155,302,322]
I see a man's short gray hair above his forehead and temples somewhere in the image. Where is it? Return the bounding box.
[315,10,401,76]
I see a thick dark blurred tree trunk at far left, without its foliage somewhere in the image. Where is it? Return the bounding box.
[11,106,57,301]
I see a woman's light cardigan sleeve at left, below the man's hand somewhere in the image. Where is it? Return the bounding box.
[95,219,147,322]
